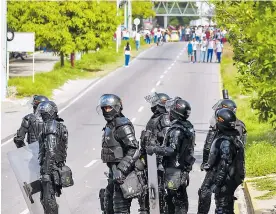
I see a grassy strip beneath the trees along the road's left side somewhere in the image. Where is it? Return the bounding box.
[9,39,150,97]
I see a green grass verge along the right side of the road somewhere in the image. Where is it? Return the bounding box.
[221,44,276,177]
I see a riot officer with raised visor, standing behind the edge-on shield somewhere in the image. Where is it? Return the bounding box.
[139,93,170,214]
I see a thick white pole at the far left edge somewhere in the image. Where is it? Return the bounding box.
[1,0,9,101]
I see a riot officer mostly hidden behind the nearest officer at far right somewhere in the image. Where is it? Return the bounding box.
[198,99,246,214]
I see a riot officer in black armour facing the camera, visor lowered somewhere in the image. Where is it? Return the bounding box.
[99,94,140,214]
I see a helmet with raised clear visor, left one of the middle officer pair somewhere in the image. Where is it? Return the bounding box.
[145,92,171,113]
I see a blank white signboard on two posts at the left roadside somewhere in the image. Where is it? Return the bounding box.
[7,32,35,82]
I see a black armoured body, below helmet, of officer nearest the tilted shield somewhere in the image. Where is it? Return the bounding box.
[39,119,69,214]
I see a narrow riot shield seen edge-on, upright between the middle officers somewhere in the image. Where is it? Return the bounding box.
[147,154,160,214]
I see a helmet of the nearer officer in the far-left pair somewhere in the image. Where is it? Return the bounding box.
[37,101,58,121]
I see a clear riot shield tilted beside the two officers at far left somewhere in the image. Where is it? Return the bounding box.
[8,142,71,214]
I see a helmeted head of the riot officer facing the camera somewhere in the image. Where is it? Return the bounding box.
[97,94,123,121]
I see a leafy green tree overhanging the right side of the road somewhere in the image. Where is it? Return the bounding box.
[214,1,276,125]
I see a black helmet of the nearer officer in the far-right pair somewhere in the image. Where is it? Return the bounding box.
[215,108,237,132]
